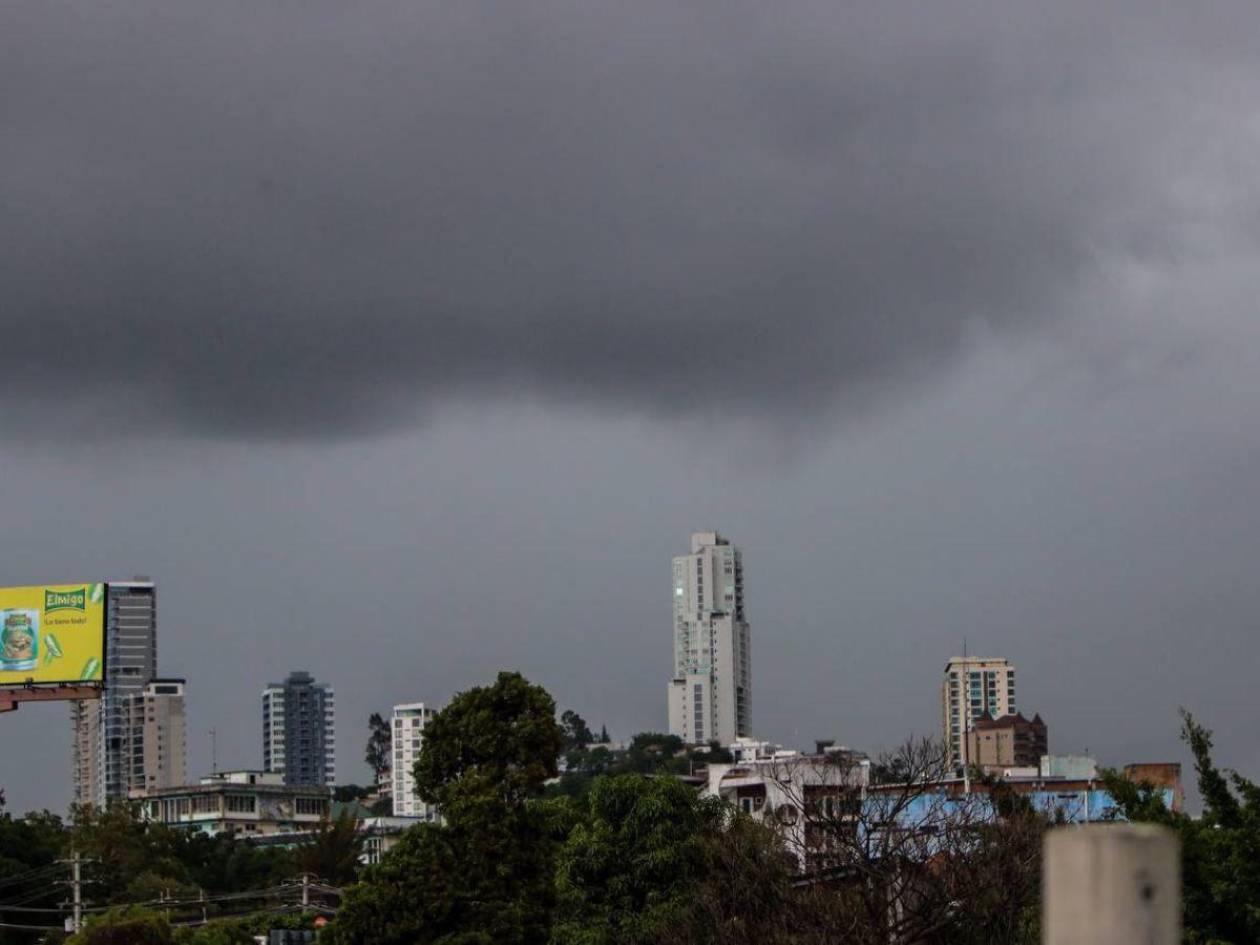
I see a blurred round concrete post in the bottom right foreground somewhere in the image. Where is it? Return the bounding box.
[1041,824,1181,945]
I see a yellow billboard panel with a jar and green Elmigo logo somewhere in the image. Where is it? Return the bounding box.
[0,583,105,687]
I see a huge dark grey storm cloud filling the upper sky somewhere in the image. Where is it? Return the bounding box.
[0,0,1257,436]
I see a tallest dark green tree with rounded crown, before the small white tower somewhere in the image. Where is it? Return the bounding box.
[329,673,566,945]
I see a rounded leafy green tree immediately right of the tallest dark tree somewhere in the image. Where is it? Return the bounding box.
[552,775,723,945]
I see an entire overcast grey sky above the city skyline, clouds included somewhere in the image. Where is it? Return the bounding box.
[0,0,1260,810]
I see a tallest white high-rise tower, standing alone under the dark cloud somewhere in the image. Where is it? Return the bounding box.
[669,532,752,745]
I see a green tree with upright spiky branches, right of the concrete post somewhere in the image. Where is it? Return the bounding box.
[1103,709,1260,945]
